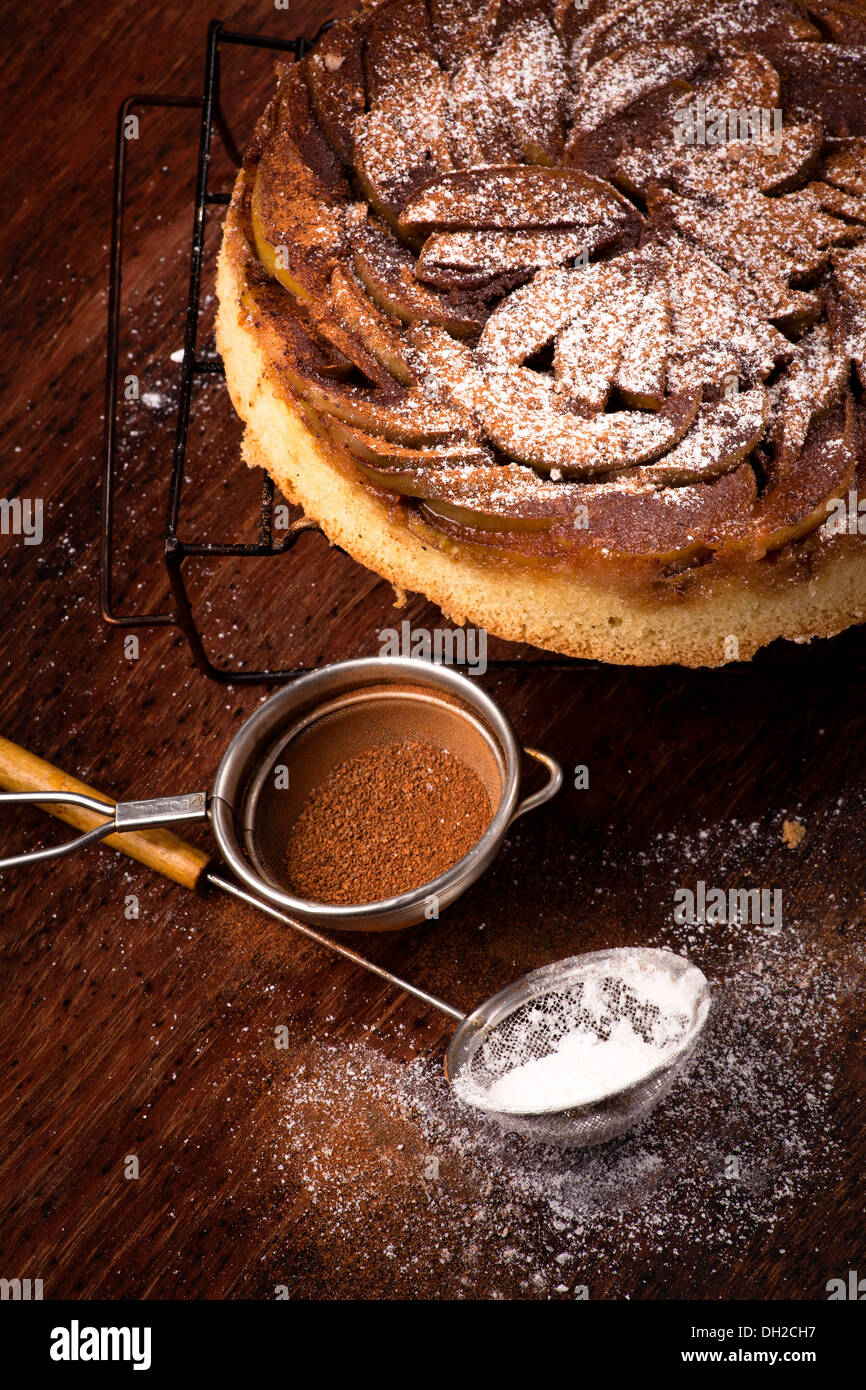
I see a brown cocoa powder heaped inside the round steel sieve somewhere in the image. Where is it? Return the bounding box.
[286,739,493,906]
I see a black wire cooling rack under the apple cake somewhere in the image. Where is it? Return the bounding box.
[99,19,595,685]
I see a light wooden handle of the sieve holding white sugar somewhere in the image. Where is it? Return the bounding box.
[0,735,210,888]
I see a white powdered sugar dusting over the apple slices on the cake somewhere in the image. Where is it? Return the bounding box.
[248,0,866,553]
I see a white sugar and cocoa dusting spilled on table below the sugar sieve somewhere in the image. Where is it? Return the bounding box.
[254,906,863,1298]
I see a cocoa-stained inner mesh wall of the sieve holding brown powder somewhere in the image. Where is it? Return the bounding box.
[242,684,506,891]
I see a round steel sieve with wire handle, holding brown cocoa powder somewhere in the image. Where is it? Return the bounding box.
[0,657,562,931]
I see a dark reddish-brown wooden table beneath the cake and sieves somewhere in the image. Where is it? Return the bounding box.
[0,0,866,1298]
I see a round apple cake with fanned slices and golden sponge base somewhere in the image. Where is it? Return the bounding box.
[217,0,866,666]
